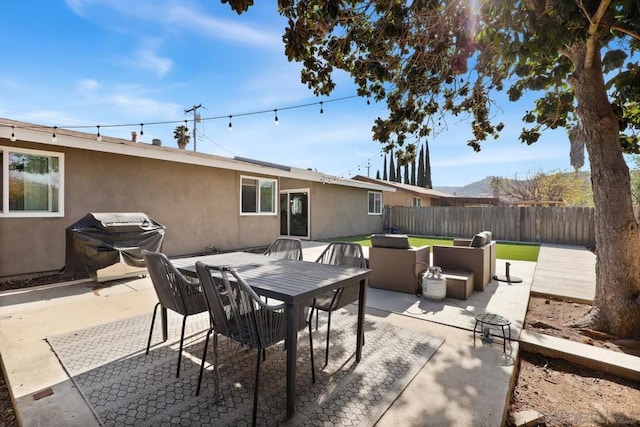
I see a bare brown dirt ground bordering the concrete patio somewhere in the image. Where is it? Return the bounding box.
[0,274,640,427]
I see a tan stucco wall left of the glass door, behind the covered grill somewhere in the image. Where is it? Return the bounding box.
[0,141,279,277]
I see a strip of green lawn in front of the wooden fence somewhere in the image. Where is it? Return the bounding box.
[327,234,540,262]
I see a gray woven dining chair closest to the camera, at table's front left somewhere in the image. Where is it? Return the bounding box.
[196,262,315,425]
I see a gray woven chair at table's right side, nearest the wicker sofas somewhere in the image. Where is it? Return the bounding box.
[309,242,367,366]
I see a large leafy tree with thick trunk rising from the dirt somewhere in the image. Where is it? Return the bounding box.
[222,0,640,336]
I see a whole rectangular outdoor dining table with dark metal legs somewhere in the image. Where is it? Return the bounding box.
[170,252,371,418]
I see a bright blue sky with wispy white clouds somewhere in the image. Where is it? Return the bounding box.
[0,0,571,186]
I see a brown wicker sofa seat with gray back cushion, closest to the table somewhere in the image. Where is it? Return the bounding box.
[369,234,430,294]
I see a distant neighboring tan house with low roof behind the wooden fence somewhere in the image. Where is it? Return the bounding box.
[353,175,502,207]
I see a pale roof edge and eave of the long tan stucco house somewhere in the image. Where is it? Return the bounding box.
[0,118,395,191]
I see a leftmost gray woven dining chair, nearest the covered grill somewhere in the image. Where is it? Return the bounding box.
[142,250,207,378]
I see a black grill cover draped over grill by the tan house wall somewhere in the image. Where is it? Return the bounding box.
[65,212,165,276]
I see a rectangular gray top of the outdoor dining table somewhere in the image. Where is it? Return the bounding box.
[172,252,371,304]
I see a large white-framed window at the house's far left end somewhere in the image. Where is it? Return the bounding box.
[0,146,64,217]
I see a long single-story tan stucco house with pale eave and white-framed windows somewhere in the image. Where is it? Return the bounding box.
[0,119,394,278]
